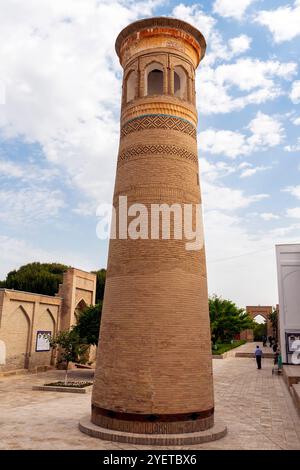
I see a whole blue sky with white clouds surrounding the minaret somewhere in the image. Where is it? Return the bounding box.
[0,0,300,306]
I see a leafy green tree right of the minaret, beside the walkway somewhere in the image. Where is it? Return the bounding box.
[208,295,254,344]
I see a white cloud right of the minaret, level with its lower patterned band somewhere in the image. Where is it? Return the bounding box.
[198,111,284,158]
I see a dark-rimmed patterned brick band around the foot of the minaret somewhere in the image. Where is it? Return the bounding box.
[92,405,214,434]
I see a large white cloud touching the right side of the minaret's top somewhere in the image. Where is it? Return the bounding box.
[172,2,297,114]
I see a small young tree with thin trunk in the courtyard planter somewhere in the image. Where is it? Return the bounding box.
[50,329,88,385]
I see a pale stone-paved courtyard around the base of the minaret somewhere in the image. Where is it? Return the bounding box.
[0,346,300,450]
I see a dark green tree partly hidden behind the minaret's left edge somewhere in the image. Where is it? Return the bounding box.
[74,302,102,346]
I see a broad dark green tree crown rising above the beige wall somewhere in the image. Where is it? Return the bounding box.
[4,262,68,295]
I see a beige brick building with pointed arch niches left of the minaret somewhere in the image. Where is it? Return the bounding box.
[0,268,96,373]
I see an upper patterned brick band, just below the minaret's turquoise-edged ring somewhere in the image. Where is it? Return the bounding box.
[121,114,197,140]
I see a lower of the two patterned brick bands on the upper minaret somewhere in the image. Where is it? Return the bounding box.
[119,144,198,164]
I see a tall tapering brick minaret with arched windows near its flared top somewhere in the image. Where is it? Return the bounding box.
[83,17,224,442]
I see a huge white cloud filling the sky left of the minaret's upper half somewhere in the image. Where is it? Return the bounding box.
[0,0,162,207]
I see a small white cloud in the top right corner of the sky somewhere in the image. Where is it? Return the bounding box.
[255,0,300,43]
